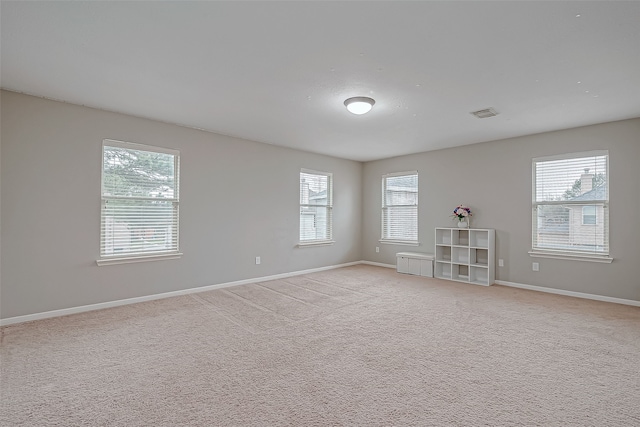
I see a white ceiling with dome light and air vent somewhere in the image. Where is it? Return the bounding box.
[0,0,640,161]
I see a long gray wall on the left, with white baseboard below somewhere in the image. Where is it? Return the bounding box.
[0,91,363,318]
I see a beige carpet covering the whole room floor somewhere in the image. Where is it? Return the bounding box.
[0,265,640,426]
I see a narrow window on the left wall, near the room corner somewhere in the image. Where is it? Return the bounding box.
[300,169,333,245]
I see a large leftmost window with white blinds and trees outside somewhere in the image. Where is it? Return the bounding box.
[98,140,180,265]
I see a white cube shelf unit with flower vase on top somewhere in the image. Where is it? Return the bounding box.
[433,228,496,286]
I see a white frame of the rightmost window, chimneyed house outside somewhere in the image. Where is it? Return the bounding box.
[529,150,613,263]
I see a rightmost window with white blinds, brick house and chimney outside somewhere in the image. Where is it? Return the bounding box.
[531,151,609,258]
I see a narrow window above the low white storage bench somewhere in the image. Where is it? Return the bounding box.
[381,171,418,244]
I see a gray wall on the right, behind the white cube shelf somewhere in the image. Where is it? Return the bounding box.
[363,119,640,301]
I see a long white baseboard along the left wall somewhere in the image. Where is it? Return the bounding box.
[0,261,362,326]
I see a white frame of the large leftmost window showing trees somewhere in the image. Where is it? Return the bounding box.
[96,139,183,266]
